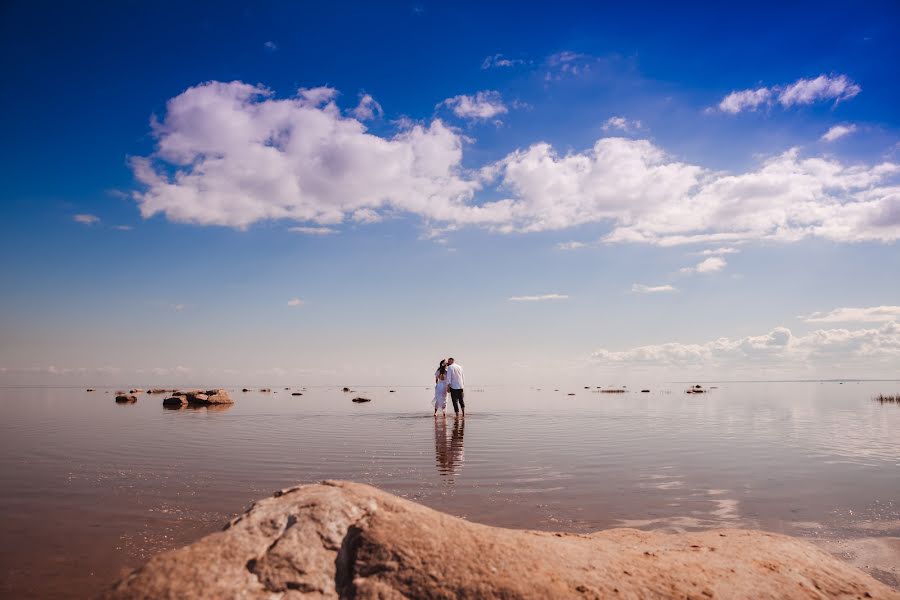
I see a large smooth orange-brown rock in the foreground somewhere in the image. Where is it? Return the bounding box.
[108,481,900,599]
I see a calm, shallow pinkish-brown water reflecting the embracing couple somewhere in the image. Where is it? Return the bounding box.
[0,382,900,598]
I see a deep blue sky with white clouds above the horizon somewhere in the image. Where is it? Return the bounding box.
[0,2,900,386]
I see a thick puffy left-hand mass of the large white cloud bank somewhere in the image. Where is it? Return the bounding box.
[131,82,503,228]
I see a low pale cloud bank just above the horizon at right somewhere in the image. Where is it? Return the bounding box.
[592,321,900,368]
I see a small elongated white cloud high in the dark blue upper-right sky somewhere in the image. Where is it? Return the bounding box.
[719,75,862,114]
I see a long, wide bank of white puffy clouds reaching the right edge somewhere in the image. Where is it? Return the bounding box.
[131,82,900,246]
